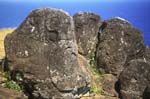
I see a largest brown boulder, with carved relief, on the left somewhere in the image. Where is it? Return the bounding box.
[5,8,90,99]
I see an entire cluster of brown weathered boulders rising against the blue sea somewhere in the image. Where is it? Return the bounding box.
[3,8,150,99]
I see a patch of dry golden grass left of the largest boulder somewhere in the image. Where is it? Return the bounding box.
[0,28,15,59]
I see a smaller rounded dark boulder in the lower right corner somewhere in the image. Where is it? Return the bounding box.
[119,59,150,99]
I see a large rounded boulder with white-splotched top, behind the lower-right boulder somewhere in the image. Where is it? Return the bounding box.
[96,18,145,75]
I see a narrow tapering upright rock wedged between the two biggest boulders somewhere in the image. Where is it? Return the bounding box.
[73,12,100,58]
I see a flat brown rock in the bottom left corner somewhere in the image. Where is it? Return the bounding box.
[0,87,27,99]
